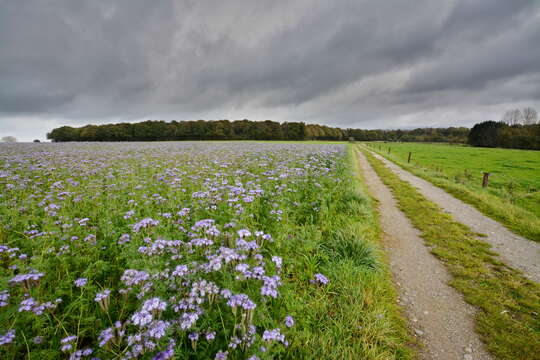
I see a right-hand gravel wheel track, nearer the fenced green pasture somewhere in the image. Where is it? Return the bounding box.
[371,152,540,283]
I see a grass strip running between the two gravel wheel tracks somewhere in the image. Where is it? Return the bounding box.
[363,150,540,360]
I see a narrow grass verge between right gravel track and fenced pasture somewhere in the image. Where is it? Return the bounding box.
[362,143,540,242]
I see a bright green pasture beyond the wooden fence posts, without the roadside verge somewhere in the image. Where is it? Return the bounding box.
[369,143,540,217]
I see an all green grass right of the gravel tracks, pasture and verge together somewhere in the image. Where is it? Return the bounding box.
[368,143,540,241]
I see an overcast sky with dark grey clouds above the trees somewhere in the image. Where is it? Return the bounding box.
[0,0,540,141]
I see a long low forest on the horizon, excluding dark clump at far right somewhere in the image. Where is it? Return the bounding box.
[47,120,469,143]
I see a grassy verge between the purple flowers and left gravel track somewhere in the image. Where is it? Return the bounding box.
[283,147,414,359]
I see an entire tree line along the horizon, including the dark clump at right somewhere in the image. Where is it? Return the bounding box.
[47,112,540,150]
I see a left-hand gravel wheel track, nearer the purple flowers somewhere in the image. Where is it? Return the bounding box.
[358,152,491,360]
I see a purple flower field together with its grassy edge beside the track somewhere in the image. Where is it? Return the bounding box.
[0,142,409,360]
